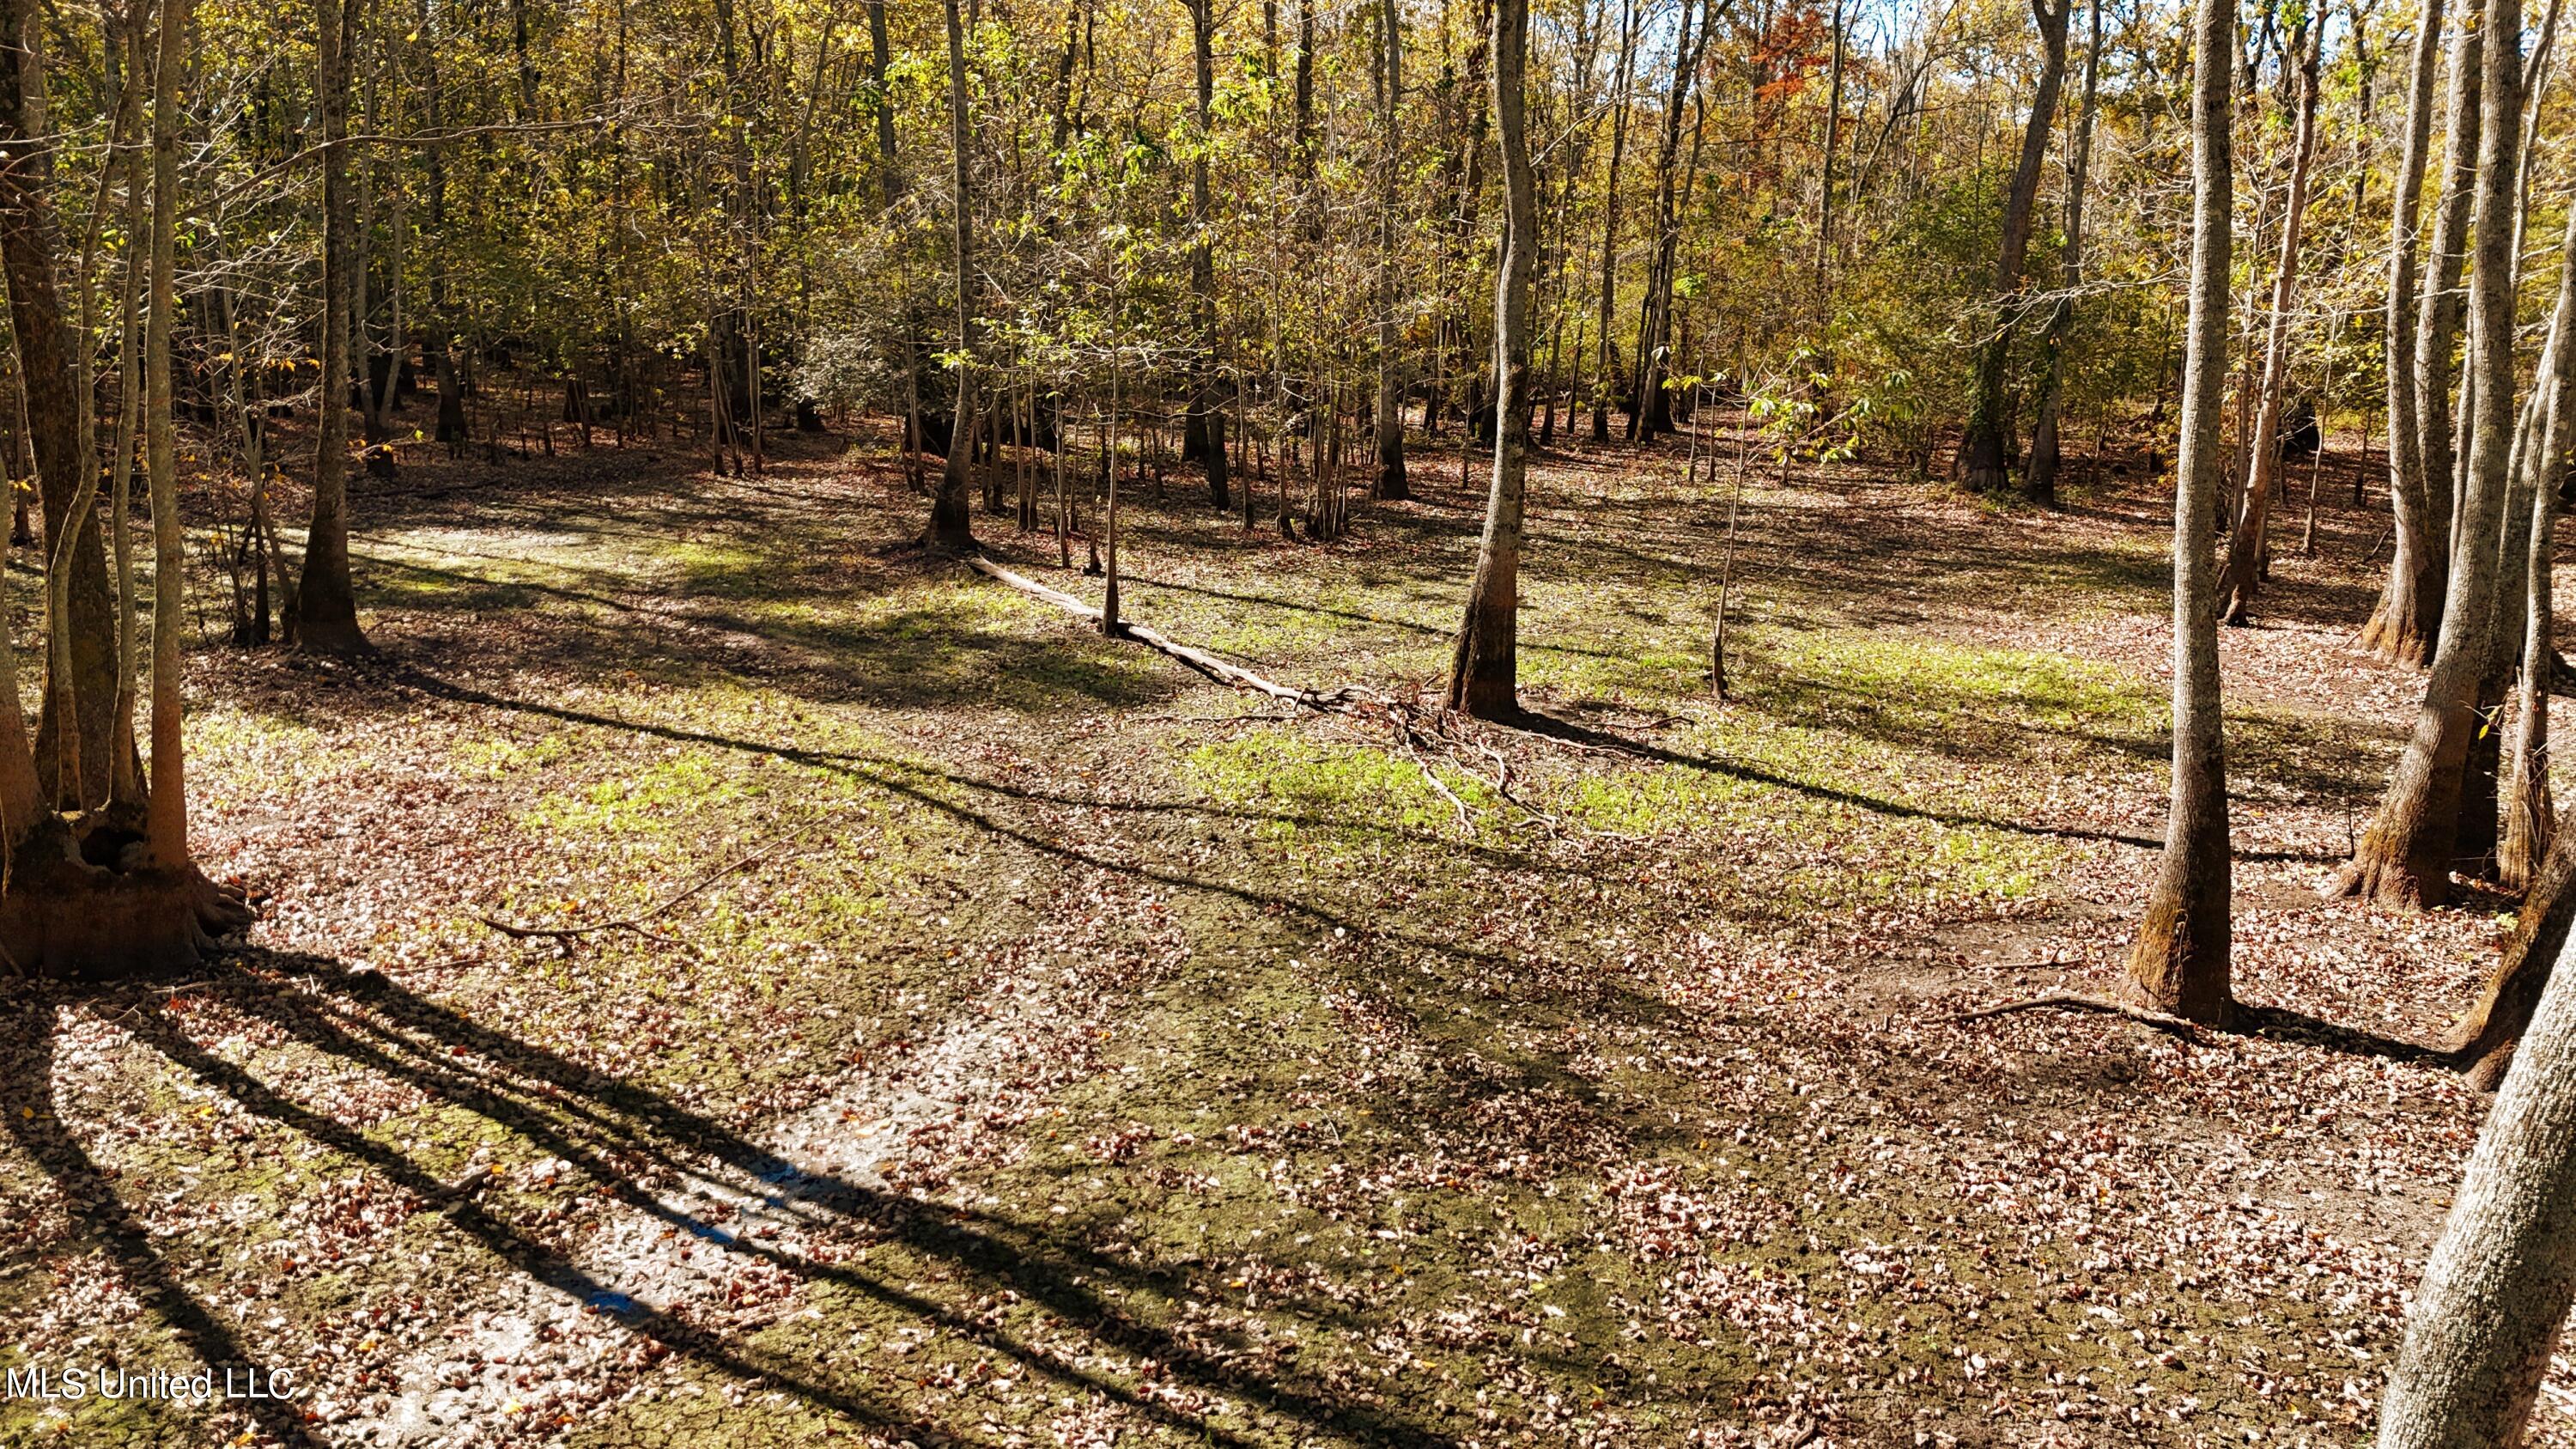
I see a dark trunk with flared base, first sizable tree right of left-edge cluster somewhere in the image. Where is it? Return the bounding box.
[296,0,366,652]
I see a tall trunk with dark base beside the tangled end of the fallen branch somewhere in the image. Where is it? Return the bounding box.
[1448,0,1538,719]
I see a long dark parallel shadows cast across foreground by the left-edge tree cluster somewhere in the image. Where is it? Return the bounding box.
[0,952,1453,1446]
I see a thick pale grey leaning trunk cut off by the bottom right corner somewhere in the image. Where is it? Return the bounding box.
[2372,897,2576,1449]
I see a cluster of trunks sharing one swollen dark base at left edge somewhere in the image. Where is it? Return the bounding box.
[0,0,247,975]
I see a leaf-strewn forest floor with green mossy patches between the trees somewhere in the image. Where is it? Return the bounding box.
[0,397,2545,1446]
